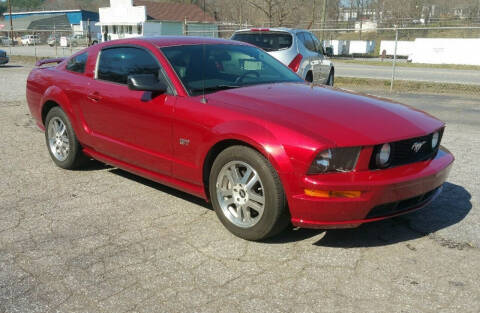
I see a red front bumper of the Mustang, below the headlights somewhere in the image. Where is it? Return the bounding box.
[289,147,454,228]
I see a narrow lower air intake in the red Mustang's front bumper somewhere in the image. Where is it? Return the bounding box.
[366,187,441,219]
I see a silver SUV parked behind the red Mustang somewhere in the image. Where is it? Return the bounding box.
[231,28,335,86]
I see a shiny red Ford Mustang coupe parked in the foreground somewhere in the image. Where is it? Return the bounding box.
[27,37,454,240]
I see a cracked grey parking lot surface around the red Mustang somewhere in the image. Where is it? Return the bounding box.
[0,59,480,313]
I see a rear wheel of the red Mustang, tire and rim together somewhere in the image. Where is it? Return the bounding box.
[45,107,86,169]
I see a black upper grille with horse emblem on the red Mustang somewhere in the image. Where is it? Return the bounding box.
[370,129,443,169]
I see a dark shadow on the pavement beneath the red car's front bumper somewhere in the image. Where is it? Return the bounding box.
[265,183,472,248]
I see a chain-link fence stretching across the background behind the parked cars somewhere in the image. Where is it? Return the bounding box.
[0,23,480,96]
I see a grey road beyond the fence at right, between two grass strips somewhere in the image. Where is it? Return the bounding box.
[334,60,480,85]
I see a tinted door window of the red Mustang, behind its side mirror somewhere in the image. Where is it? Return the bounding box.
[97,47,161,84]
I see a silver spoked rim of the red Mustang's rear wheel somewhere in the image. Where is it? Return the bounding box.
[47,117,70,161]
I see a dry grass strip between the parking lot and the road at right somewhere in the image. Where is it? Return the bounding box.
[335,77,480,96]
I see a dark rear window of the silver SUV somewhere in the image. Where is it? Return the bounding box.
[232,31,292,51]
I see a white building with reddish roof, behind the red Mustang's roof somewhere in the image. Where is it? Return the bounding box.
[97,0,218,40]
